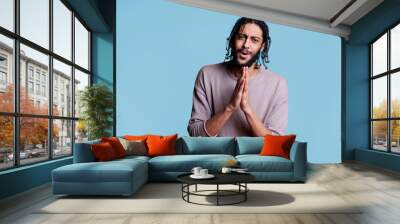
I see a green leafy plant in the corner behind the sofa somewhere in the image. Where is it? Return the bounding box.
[79,84,113,140]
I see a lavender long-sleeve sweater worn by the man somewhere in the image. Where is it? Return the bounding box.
[188,63,288,136]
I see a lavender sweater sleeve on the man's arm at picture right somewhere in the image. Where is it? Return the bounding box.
[265,79,288,135]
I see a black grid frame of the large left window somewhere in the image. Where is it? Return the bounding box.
[0,0,93,172]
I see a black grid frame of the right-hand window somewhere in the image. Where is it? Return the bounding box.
[368,21,400,155]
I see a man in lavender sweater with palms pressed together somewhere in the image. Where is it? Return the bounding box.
[188,18,288,136]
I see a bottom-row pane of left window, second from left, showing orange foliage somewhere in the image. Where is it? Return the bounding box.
[19,117,49,164]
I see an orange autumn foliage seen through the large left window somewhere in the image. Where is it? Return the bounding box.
[0,85,59,152]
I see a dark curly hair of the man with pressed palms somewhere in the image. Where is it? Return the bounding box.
[224,17,271,69]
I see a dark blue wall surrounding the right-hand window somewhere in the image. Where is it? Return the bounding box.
[343,0,400,170]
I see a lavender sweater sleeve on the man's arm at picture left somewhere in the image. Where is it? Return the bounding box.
[187,69,216,136]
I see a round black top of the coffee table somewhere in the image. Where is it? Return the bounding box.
[177,173,255,184]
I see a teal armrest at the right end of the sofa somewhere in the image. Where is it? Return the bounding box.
[290,141,307,181]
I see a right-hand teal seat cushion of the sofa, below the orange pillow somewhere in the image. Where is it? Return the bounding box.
[236,155,293,172]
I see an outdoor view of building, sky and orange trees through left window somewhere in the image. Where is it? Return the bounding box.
[0,0,91,171]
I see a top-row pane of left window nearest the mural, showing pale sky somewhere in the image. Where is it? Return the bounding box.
[75,18,89,70]
